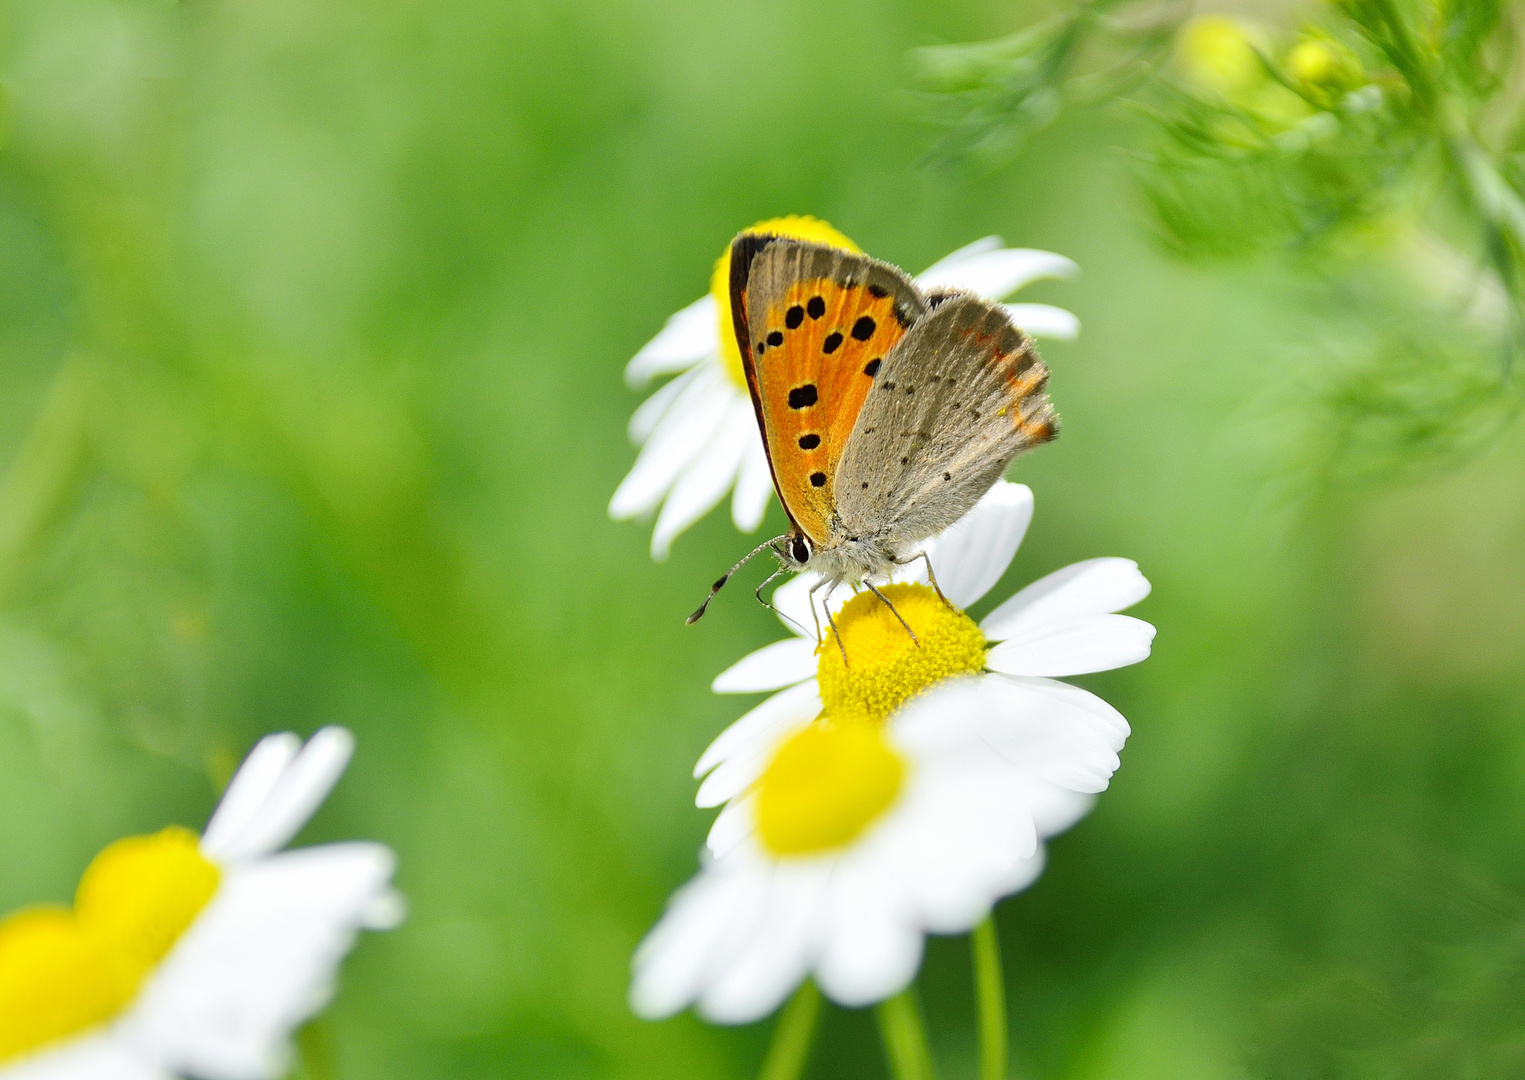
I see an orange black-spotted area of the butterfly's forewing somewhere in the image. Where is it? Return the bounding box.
[746,278,906,545]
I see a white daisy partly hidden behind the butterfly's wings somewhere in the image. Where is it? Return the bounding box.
[608,217,1080,560]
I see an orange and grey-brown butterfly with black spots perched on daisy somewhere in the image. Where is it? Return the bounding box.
[688,232,1058,638]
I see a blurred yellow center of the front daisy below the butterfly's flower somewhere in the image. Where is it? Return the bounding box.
[756,718,906,856]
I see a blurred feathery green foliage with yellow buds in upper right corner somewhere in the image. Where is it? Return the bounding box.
[917,0,1525,481]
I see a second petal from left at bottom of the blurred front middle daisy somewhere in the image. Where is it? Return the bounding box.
[698,862,830,1024]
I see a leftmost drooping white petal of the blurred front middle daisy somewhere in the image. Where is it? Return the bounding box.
[630,859,767,1021]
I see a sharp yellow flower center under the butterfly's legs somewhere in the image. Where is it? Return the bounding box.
[816,584,985,723]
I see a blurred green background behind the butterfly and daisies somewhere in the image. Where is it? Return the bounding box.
[0,0,1525,1080]
